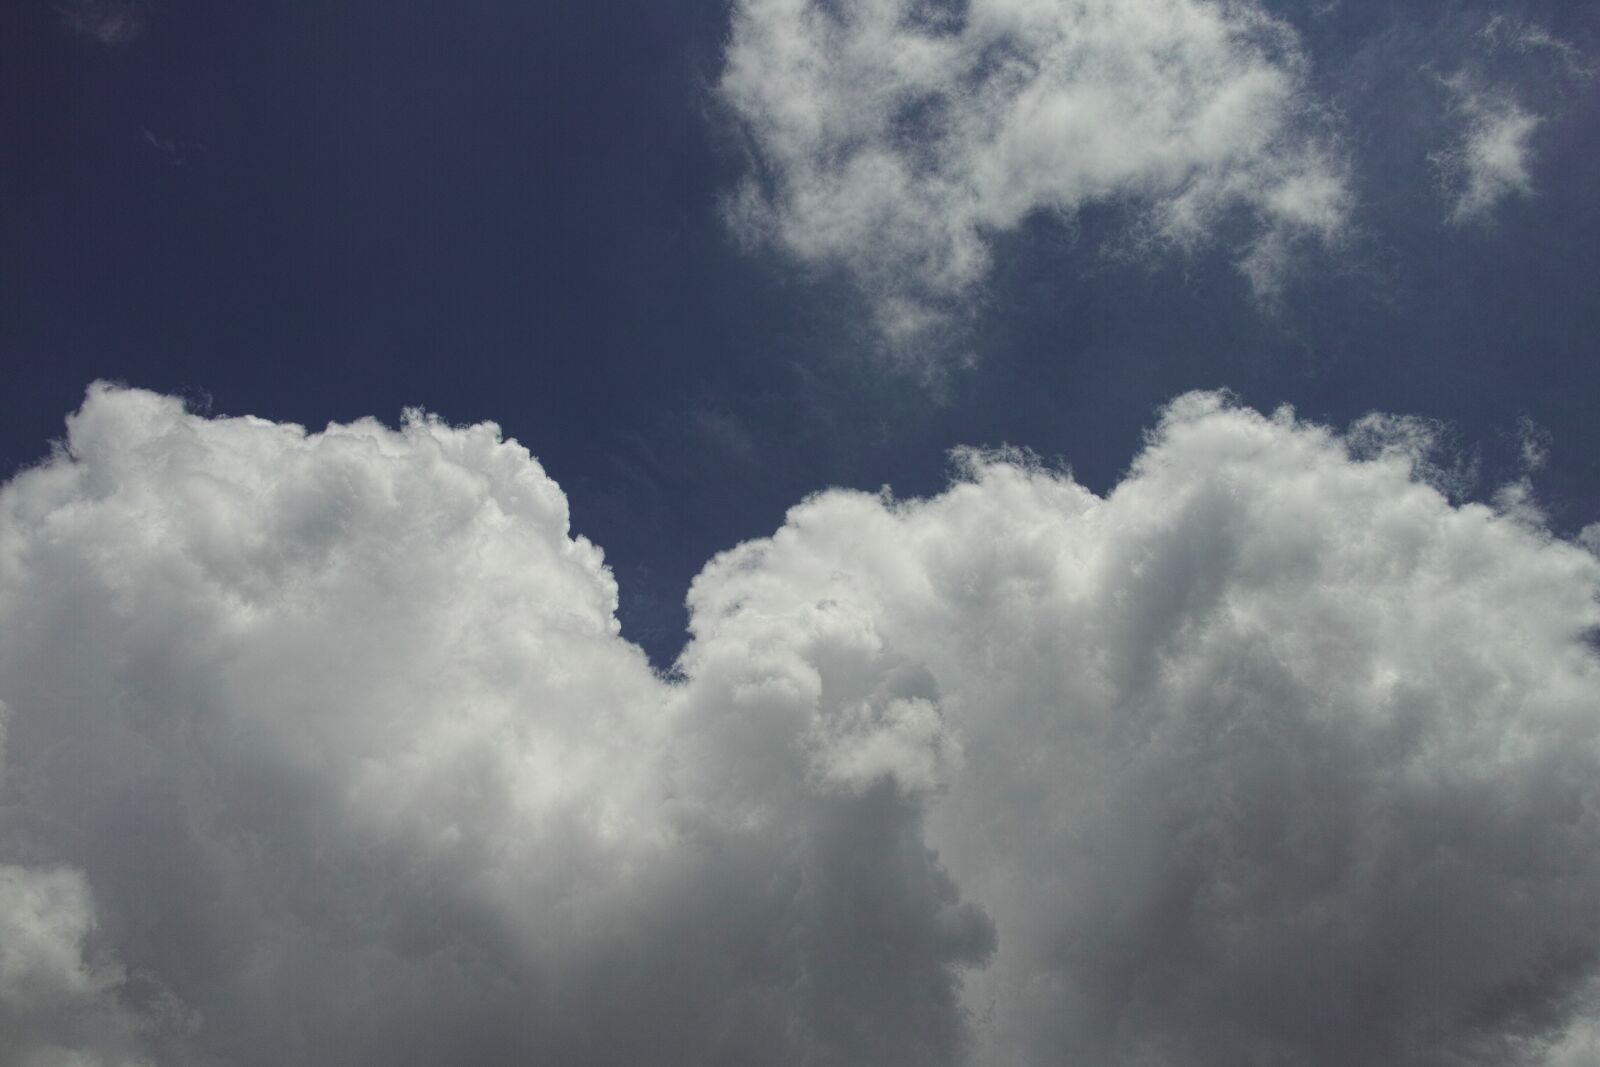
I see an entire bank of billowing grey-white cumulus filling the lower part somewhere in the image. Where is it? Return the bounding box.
[0,386,1600,1067]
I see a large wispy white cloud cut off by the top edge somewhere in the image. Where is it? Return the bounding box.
[718,0,1350,349]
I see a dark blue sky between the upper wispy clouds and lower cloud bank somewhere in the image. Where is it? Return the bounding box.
[0,0,1600,662]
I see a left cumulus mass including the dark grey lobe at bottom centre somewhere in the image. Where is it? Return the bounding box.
[0,387,990,1065]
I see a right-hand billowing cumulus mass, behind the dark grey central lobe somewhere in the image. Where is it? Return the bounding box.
[690,397,1600,1065]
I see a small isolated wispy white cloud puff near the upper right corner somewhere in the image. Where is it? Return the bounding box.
[1429,75,1542,224]
